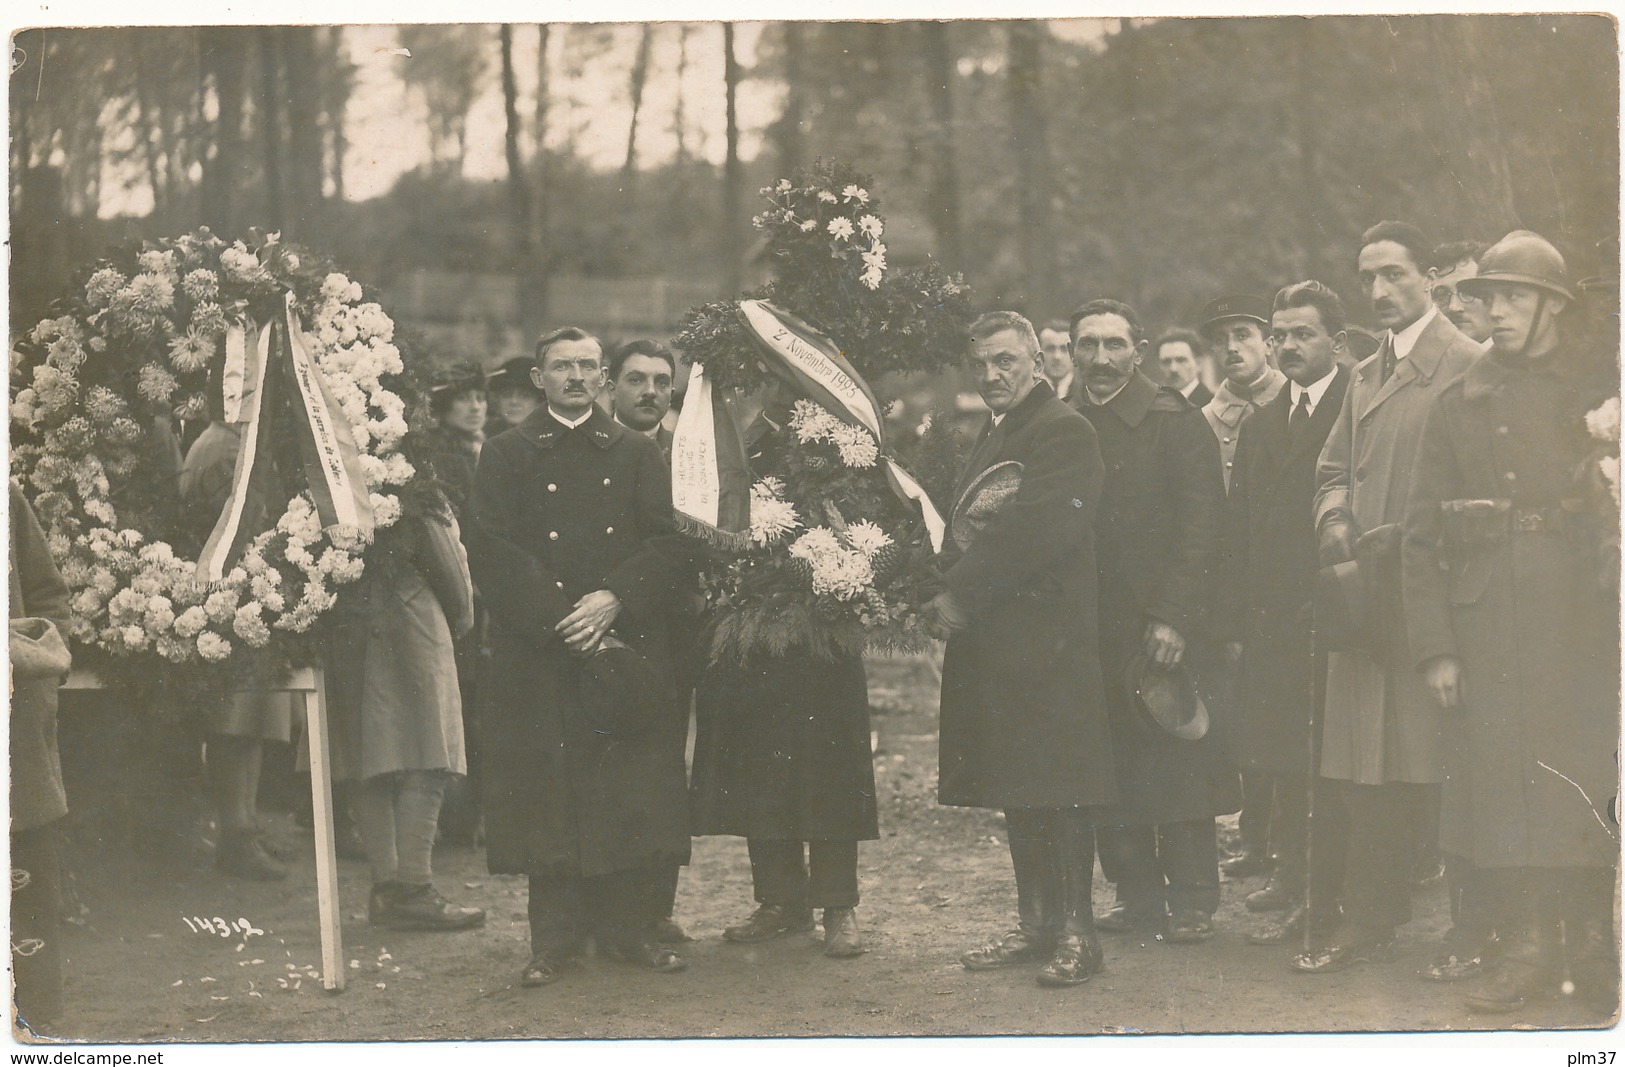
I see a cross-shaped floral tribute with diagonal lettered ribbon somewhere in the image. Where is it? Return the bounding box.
[676,162,970,661]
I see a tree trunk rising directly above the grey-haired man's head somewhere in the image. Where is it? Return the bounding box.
[1006,21,1056,313]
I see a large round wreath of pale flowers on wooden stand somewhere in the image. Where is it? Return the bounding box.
[11,229,427,690]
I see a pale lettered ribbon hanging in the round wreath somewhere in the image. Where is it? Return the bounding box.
[198,292,372,581]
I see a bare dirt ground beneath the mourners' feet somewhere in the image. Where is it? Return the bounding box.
[19,659,1614,1048]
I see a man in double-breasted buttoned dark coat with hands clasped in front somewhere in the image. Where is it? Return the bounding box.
[468,328,691,986]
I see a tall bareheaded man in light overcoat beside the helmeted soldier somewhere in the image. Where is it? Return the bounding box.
[1292,222,1482,974]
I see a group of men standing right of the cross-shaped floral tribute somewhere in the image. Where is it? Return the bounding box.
[931,222,1619,1013]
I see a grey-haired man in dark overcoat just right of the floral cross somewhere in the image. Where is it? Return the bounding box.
[926,312,1118,986]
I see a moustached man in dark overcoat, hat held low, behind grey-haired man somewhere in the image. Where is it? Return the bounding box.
[1073,300,1242,942]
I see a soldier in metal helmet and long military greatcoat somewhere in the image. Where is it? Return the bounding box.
[1402,231,1620,1015]
